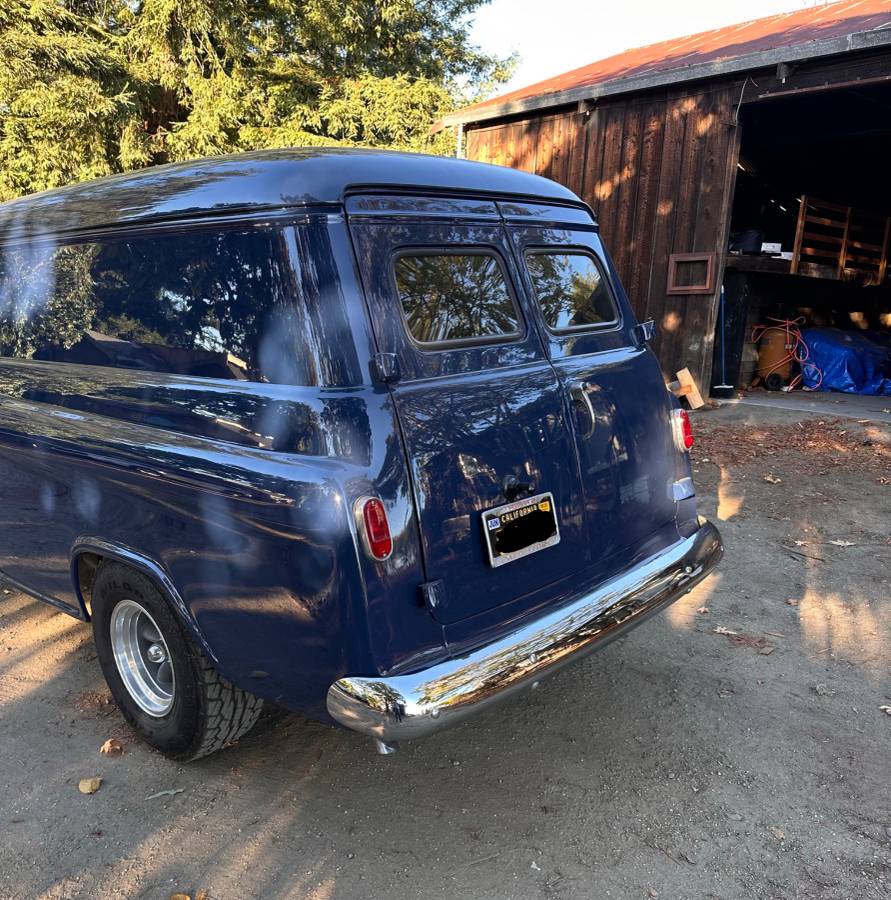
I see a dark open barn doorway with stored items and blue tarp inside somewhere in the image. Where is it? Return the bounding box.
[712,82,891,396]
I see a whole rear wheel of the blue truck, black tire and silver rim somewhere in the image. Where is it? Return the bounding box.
[92,562,263,761]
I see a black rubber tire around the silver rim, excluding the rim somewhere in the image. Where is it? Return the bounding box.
[92,562,263,762]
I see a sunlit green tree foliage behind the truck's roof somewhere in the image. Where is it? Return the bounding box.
[0,0,512,199]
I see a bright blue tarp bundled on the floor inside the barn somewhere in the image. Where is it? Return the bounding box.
[801,328,891,396]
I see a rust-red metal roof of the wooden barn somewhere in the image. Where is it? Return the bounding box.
[457,0,891,119]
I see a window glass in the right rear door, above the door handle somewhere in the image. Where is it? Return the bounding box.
[526,250,619,331]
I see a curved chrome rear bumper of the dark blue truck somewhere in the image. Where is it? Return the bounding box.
[327,520,724,744]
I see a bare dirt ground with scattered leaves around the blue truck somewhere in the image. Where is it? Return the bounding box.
[0,405,891,900]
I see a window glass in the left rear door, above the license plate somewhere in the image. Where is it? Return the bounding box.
[394,252,520,346]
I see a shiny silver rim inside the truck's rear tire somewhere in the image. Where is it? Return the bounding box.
[111,600,176,718]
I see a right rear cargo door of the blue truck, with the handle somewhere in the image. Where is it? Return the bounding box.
[501,203,677,574]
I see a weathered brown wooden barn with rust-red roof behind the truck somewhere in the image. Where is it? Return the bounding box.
[442,0,891,394]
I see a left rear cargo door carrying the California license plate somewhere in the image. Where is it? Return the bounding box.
[348,197,588,624]
